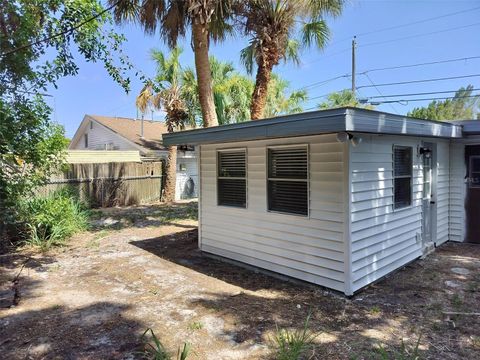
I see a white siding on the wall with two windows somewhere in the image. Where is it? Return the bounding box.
[200,135,346,292]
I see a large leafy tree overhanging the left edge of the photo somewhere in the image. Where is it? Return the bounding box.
[0,0,130,240]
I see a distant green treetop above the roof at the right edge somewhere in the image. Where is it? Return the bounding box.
[407,85,480,120]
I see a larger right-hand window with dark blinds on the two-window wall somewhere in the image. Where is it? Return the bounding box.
[267,146,308,216]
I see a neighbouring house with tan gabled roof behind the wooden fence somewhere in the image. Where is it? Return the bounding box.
[69,115,198,199]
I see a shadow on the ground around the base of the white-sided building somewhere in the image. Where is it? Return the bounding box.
[132,231,480,359]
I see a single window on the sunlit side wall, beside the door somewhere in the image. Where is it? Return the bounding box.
[393,146,413,209]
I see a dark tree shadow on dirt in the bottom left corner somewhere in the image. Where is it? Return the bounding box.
[0,302,144,359]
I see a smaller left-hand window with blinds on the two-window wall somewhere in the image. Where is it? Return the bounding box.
[217,149,247,208]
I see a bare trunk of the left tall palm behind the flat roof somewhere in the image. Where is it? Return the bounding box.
[192,24,218,127]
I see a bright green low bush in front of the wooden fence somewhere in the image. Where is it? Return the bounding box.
[19,190,89,250]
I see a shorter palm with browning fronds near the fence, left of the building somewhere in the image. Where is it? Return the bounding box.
[136,47,191,202]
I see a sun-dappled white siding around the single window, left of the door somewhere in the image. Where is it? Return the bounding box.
[350,135,423,291]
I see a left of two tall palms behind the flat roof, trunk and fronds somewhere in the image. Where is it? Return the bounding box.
[109,0,233,127]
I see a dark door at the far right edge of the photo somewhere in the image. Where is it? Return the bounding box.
[465,145,480,244]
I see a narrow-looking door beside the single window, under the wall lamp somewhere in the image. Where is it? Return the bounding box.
[420,143,436,246]
